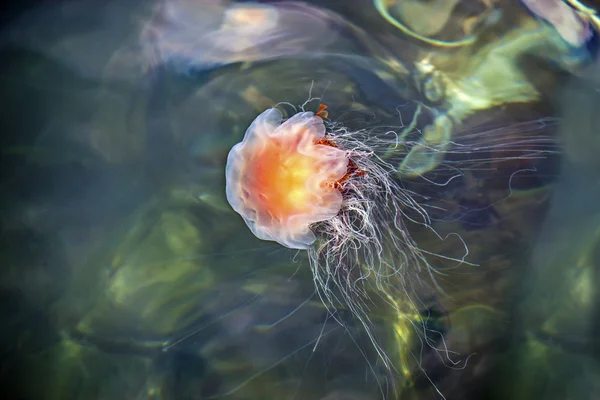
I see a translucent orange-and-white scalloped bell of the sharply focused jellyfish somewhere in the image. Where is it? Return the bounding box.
[226,108,350,249]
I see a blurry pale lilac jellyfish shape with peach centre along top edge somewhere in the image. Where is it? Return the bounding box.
[140,0,339,71]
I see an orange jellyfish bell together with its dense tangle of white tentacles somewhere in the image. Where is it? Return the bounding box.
[226,104,448,363]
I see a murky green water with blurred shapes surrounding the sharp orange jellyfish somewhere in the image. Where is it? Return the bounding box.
[0,0,600,400]
